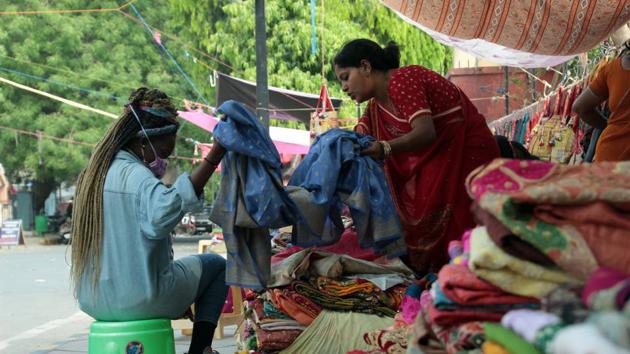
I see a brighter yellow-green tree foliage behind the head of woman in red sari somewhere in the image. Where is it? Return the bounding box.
[169,0,452,116]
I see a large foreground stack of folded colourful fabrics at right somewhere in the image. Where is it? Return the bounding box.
[408,159,630,354]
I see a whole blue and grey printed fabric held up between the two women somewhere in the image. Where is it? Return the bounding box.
[210,101,406,288]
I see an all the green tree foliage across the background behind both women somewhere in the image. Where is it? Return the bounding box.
[0,0,451,207]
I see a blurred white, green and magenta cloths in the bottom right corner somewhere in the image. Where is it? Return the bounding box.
[482,274,630,354]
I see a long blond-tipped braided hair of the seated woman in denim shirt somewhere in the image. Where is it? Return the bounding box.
[70,87,178,296]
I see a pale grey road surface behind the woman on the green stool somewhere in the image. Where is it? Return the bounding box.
[0,237,235,354]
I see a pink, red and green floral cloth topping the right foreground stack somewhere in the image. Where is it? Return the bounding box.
[467,159,630,280]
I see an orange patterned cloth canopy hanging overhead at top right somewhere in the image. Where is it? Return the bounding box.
[381,0,630,56]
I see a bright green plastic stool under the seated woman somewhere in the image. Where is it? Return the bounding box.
[88,319,175,354]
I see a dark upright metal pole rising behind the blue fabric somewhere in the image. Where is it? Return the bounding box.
[256,0,269,129]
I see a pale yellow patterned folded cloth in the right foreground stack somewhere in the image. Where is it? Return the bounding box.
[469,227,580,299]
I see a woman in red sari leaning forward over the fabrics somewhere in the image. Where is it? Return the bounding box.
[334,39,499,274]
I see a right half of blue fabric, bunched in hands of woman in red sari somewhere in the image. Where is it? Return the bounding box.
[289,129,405,256]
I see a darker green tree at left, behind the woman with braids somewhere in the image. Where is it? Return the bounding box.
[0,0,208,210]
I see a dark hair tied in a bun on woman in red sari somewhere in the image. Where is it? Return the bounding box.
[334,38,400,71]
